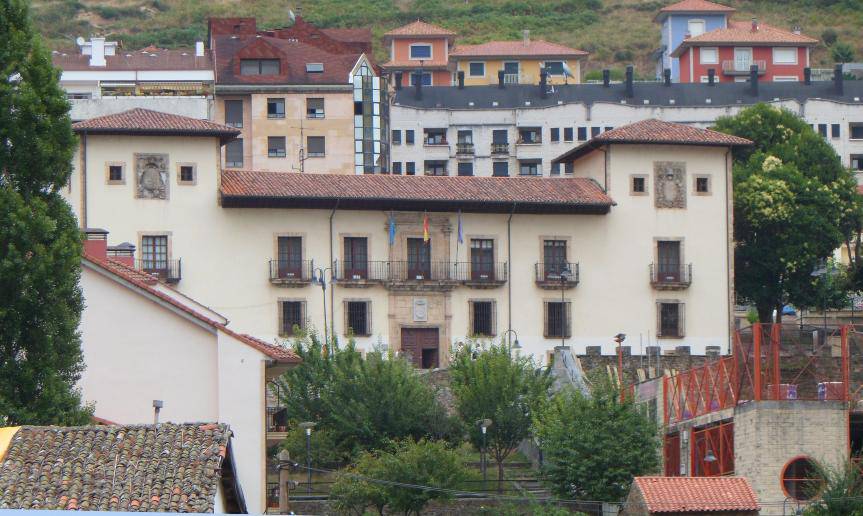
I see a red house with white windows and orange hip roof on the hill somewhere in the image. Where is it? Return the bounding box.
[671,19,818,82]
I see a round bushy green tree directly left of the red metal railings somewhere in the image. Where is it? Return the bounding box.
[536,375,659,501]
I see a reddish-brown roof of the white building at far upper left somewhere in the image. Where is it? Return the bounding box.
[51,48,213,71]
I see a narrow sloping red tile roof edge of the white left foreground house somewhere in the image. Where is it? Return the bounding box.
[83,253,300,363]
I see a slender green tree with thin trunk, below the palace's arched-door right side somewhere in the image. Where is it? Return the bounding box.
[450,342,552,488]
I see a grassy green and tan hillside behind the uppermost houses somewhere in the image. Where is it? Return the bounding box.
[34,0,863,75]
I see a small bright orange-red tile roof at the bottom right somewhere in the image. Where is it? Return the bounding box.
[633,477,761,513]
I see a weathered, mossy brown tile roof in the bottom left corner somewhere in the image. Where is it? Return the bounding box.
[0,423,231,513]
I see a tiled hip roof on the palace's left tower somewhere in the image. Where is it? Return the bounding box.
[72,108,240,139]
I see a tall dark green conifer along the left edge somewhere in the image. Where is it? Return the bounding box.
[0,0,89,425]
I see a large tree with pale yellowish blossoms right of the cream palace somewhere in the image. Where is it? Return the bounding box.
[715,104,857,321]
